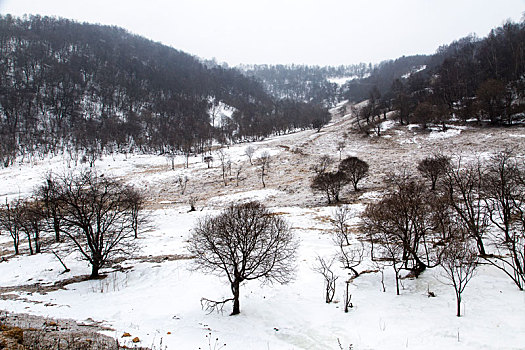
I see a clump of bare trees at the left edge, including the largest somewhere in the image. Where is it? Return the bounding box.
[0,171,146,278]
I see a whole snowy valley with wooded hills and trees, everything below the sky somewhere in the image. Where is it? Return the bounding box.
[0,15,525,350]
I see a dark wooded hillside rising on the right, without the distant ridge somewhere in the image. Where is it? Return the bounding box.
[345,21,525,128]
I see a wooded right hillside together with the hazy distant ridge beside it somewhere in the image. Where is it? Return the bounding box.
[246,17,525,130]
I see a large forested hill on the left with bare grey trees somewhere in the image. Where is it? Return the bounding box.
[0,15,329,166]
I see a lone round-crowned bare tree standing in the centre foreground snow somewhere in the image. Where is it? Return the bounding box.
[188,202,297,315]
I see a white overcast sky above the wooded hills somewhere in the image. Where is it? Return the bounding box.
[0,0,525,65]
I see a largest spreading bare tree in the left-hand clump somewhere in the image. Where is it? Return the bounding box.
[51,172,139,278]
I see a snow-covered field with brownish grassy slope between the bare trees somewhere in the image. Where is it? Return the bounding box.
[0,113,525,350]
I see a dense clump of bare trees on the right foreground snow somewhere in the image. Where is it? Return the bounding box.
[362,150,525,316]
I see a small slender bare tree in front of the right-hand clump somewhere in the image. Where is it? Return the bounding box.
[441,240,478,317]
